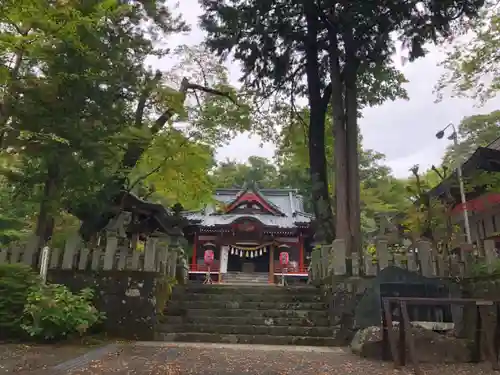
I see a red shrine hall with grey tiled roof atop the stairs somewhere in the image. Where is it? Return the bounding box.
[184,188,313,283]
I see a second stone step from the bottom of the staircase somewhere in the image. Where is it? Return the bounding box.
[158,324,333,337]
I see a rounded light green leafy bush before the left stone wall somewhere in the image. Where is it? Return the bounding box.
[22,284,104,341]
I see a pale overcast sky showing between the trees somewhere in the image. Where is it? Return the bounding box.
[159,0,500,177]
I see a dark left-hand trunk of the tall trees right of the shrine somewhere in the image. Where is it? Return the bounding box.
[304,1,335,243]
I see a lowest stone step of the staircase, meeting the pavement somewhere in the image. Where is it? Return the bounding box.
[156,332,338,346]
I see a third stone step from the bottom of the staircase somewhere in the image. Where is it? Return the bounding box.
[159,316,329,327]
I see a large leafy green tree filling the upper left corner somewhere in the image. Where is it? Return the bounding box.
[0,0,172,245]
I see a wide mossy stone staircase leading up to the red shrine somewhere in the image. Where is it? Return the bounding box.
[156,284,338,346]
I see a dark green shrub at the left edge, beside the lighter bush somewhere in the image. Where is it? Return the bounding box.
[0,263,41,338]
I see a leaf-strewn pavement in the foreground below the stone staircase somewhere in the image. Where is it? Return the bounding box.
[43,342,492,375]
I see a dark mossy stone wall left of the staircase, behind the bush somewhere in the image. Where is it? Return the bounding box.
[47,270,158,340]
